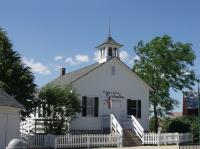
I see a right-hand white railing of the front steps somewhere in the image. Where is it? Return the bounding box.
[128,115,144,142]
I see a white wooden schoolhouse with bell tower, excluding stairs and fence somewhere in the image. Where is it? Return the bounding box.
[49,35,151,130]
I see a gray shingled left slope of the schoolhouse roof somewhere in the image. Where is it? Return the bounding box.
[48,63,104,86]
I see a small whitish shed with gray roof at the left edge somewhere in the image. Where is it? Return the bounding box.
[0,88,23,149]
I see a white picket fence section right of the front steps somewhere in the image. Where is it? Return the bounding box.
[142,133,192,145]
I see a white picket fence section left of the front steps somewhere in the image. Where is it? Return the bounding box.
[21,133,122,149]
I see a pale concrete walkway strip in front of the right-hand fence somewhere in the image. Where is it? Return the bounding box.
[96,145,179,149]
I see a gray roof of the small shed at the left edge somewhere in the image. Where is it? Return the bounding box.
[0,88,24,108]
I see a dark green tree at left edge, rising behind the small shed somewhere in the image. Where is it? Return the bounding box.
[0,28,37,117]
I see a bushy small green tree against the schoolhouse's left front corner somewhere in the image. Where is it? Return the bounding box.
[38,85,80,134]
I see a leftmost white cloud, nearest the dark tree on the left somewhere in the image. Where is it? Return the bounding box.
[22,57,51,75]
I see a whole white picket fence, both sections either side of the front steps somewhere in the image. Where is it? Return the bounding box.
[21,133,192,149]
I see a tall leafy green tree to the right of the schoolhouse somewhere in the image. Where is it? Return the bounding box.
[133,35,196,132]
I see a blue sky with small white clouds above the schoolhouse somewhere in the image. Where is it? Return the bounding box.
[0,0,200,110]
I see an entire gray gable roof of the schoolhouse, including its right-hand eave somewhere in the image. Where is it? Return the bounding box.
[48,57,153,91]
